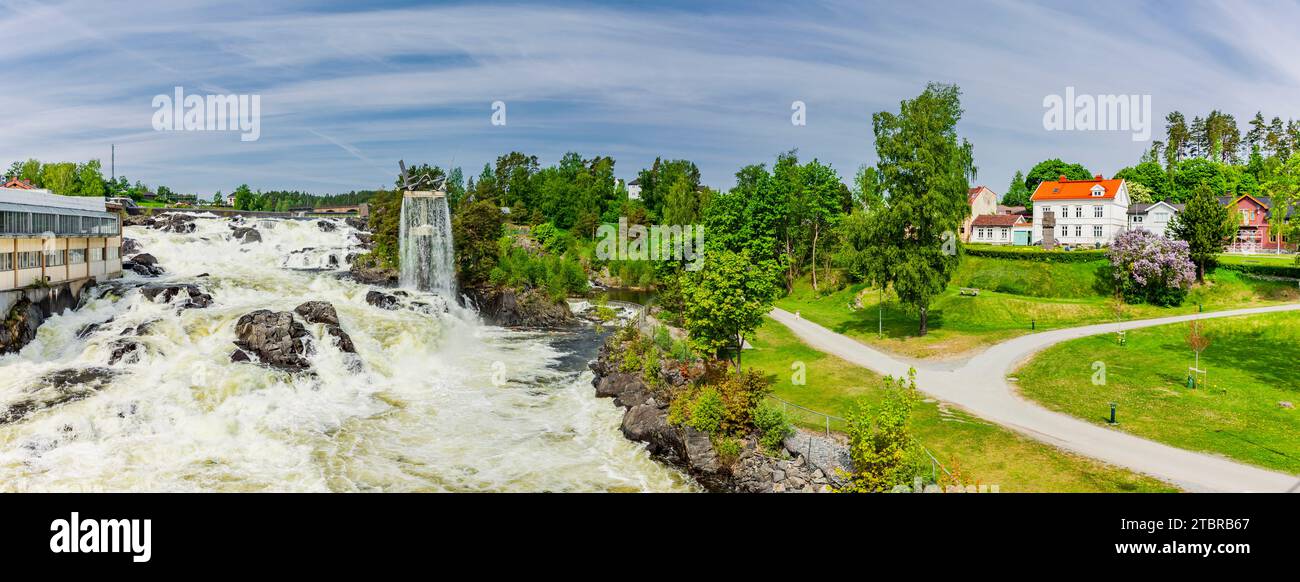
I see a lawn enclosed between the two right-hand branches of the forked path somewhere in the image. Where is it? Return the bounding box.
[1017,313,1300,473]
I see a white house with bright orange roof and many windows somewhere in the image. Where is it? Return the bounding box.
[1031,175,1130,247]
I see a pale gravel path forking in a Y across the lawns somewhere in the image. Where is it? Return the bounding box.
[771,304,1300,491]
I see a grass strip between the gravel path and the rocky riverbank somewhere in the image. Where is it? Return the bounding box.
[744,320,1177,491]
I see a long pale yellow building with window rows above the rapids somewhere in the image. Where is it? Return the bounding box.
[0,188,122,291]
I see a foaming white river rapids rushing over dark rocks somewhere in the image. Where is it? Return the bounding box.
[0,218,693,491]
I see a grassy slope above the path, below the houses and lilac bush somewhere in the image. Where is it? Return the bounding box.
[776,256,1300,359]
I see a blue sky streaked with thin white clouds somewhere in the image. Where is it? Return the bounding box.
[0,0,1300,194]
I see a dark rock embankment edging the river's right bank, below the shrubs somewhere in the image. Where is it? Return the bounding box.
[590,336,849,492]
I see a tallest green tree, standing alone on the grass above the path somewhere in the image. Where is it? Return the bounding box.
[871,83,975,335]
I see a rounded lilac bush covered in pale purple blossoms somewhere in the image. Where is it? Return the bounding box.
[1106,230,1196,305]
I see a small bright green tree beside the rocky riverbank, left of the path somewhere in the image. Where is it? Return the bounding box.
[680,251,780,370]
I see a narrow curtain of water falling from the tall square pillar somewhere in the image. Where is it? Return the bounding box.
[399,192,456,301]
